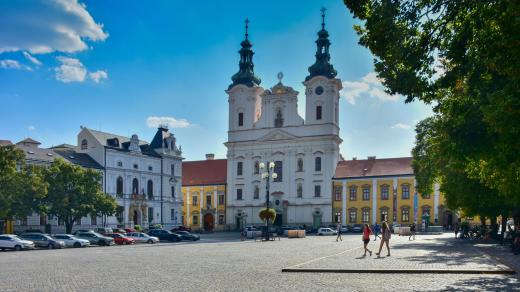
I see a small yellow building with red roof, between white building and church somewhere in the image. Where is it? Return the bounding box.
[182,154,227,231]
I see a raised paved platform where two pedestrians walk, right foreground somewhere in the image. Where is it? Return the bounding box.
[284,230,514,274]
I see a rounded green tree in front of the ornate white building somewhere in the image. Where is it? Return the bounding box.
[45,159,115,233]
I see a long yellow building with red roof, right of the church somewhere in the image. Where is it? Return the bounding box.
[332,156,457,227]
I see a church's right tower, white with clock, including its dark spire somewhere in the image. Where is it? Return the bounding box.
[303,8,342,135]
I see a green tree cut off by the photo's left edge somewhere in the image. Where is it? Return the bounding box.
[0,146,47,224]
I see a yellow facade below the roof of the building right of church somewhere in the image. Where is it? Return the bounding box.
[332,176,450,225]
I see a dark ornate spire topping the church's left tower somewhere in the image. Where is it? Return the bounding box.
[229,18,261,88]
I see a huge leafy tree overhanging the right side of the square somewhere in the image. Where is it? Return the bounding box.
[344,0,520,224]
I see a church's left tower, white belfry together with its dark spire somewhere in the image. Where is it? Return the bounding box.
[226,19,264,132]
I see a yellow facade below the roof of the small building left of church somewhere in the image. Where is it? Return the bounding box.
[182,185,226,231]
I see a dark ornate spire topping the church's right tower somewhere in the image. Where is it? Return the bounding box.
[305,8,338,81]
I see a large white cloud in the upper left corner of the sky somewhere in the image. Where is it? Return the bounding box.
[0,0,108,54]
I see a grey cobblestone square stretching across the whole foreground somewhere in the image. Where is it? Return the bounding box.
[0,233,520,291]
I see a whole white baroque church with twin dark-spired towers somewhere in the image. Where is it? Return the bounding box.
[226,14,342,228]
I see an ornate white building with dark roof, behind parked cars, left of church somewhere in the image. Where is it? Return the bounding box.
[77,127,183,228]
